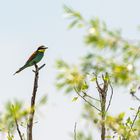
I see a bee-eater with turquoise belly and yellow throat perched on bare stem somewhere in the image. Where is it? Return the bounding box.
[14,45,48,75]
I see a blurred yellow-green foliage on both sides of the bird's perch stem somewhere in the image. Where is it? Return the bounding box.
[0,95,47,140]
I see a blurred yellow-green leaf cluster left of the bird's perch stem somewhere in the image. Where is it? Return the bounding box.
[0,100,29,137]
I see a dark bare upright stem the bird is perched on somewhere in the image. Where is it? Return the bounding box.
[27,64,39,140]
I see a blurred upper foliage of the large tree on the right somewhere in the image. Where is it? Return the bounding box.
[57,6,140,91]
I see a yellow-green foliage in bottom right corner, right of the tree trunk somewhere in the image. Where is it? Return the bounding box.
[106,110,140,140]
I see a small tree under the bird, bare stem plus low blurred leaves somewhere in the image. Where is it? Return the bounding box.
[0,64,46,140]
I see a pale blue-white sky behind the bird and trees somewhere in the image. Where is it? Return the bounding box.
[0,0,140,140]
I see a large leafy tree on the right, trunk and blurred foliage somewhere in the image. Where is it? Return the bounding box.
[56,6,140,140]
